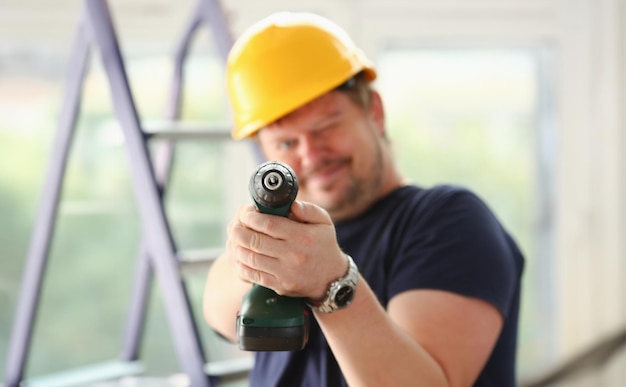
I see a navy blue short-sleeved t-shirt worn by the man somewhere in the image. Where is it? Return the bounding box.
[250,186,524,387]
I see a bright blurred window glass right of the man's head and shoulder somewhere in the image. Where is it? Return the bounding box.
[377,49,550,375]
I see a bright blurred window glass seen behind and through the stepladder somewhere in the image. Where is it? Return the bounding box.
[0,42,241,377]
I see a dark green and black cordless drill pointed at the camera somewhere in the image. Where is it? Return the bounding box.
[237,161,309,351]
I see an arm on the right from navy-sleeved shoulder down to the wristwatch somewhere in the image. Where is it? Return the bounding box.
[316,194,516,386]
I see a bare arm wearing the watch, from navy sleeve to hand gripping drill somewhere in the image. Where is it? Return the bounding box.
[224,202,503,387]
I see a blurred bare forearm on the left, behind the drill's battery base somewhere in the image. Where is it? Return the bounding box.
[203,256,251,342]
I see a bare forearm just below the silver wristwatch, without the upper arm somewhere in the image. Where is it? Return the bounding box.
[315,278,448,387]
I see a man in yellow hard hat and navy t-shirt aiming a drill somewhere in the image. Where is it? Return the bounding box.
[204,13,523,387]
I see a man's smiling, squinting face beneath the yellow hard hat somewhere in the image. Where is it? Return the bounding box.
[258,91,385,221]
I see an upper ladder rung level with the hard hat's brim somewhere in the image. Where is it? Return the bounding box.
[144,121,232,141]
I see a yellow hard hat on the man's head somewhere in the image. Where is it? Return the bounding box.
[226,12,376,140]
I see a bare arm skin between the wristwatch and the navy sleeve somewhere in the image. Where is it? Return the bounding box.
[315,278,502,387]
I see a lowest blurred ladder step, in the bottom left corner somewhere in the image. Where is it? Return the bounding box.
[24,360,144,387]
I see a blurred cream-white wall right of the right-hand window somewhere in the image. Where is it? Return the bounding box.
[555,0,626,362]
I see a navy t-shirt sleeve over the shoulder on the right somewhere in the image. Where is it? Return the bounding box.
[388,188,521,318]
